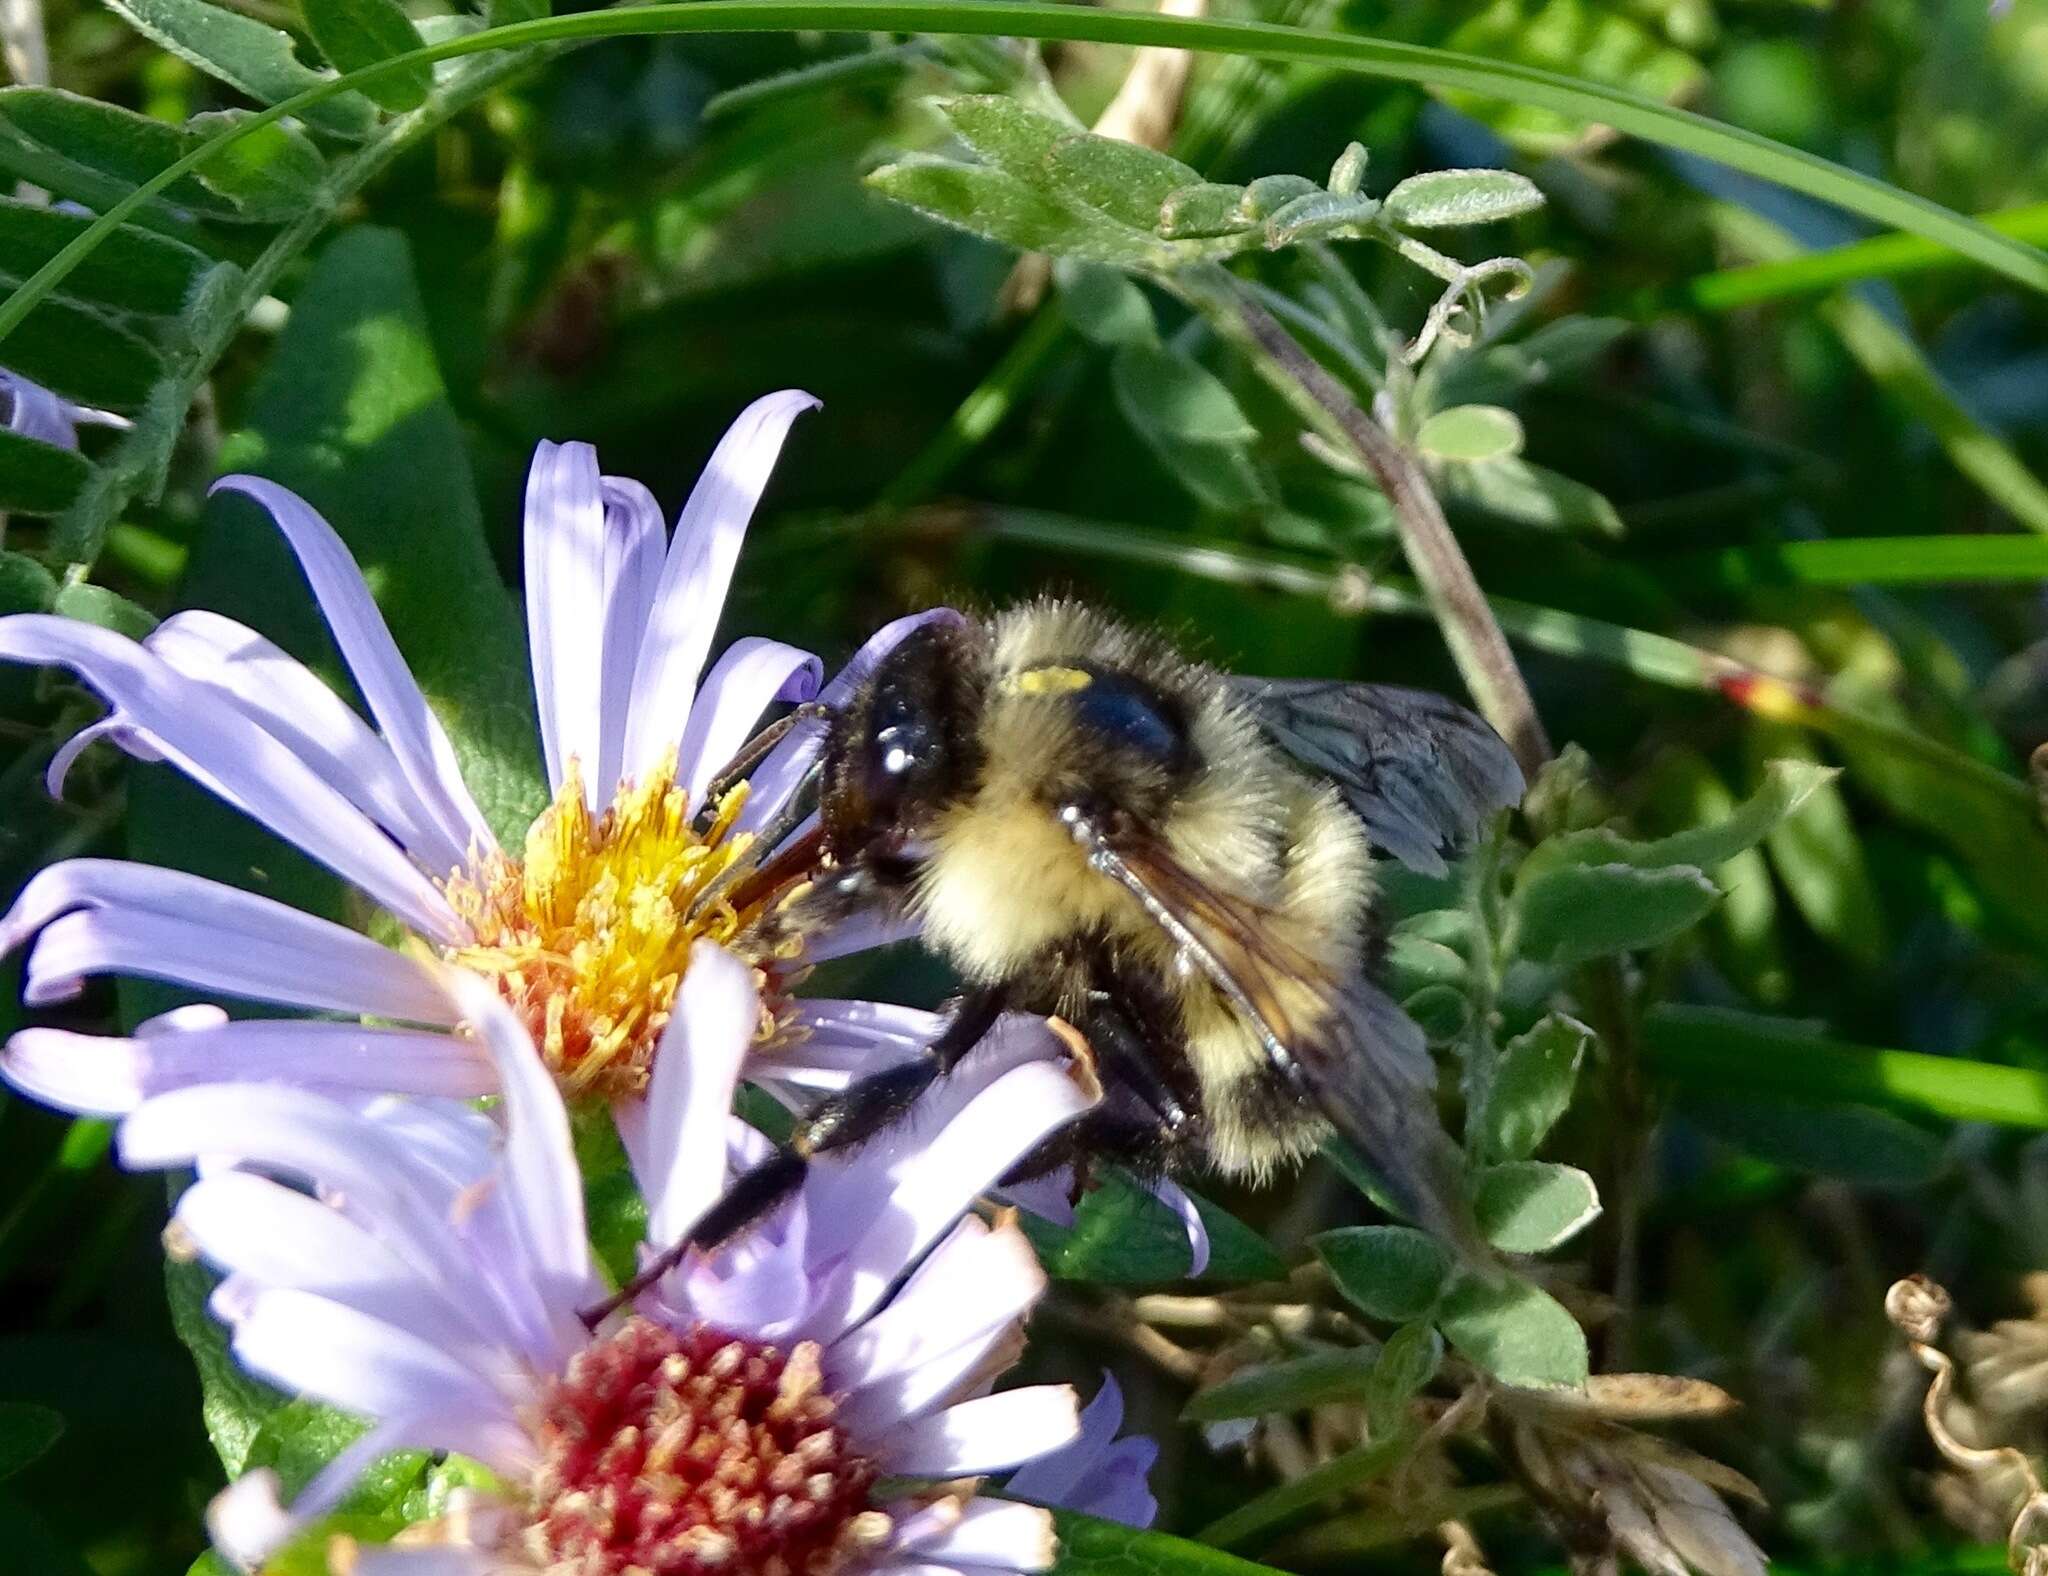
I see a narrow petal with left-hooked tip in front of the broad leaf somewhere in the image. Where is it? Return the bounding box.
[209,477,498,851]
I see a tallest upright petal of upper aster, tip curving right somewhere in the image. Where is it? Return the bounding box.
[621,389,817,776]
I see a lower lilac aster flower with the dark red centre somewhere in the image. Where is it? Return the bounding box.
[130,942,1145,1576]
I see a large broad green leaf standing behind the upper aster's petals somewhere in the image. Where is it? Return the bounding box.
[208,227,545,847]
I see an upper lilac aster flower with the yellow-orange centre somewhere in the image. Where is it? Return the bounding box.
[0,391,942,1111]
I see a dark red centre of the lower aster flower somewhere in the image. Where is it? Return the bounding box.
[524,1318,891,1576]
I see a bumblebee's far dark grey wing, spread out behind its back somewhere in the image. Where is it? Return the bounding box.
[1231,680,1524,876]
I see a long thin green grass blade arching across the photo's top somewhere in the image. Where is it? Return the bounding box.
[0,0,2048,338]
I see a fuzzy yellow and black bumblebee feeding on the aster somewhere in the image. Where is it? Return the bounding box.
[593,602,1522,1309]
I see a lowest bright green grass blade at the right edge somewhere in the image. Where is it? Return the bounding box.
[1642,1005,2048,1128]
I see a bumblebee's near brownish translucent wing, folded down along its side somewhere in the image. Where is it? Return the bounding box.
[1067,802,1485,1259]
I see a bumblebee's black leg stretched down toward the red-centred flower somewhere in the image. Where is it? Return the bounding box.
[578,987,1006,1328]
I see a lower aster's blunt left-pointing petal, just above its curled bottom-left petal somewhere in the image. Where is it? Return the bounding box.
[233,1289,512,1420]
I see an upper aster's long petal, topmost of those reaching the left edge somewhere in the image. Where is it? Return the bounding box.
[0,614,463,942]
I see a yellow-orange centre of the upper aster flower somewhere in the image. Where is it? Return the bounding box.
[442,755,778,1097]
